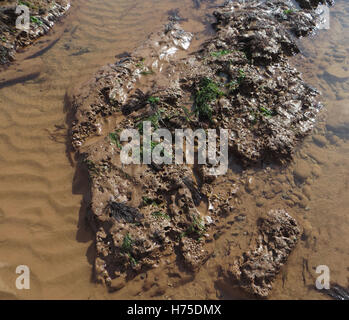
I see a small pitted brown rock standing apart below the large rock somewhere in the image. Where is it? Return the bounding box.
[227,210,300,298]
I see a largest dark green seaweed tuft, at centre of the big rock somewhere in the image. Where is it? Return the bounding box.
[194,78,224,120]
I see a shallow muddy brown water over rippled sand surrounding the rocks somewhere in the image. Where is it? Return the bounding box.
[0,0,349,299]
